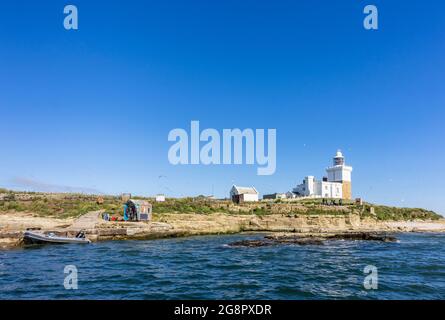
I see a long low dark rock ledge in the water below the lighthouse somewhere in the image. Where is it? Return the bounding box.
[229,232,397,247]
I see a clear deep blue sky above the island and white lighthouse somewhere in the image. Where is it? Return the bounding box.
[0,0,445,214]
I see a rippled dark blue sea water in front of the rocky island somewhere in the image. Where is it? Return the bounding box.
[0,234,445,299]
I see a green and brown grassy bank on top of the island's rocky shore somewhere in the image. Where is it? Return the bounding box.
[0,189,441,221]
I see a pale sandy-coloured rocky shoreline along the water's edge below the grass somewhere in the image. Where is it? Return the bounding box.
[0,211,445,249]
